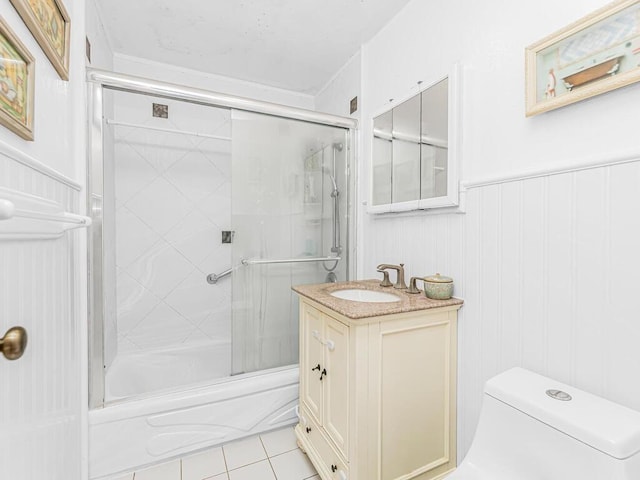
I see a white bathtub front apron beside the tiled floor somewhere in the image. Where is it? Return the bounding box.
[89,346,298,479]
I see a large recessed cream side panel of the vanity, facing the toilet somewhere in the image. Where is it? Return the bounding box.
[378,313,455,480]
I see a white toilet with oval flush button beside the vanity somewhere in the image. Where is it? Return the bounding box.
[446,368,640,480]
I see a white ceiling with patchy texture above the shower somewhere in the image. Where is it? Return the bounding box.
[96,0,410,95]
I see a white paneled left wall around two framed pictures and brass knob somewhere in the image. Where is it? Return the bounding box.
[0,0,87,480]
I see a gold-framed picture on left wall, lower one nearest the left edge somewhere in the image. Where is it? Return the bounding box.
[0,17,35,140]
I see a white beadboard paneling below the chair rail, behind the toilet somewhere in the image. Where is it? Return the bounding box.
[360,158,640,459]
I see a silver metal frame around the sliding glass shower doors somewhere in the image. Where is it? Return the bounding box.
[87,69,358,409]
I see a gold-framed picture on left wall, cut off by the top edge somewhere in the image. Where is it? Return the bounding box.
[10,0,71,80]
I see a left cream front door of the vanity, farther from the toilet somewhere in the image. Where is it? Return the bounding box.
[300,305,326,425]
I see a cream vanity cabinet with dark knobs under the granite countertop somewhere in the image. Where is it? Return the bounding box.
[296,287,462,480]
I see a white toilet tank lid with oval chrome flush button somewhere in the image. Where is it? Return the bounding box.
[484,368,640,460]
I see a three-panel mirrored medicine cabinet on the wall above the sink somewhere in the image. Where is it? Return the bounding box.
[368,65,461,213]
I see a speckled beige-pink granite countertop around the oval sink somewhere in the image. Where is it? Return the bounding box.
[291,280,463,319]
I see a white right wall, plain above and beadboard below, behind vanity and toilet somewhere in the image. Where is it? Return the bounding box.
[338,0,640,458]
